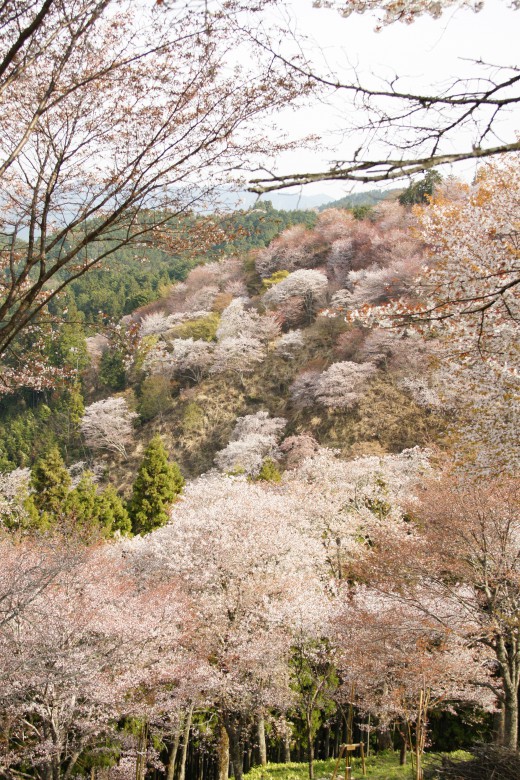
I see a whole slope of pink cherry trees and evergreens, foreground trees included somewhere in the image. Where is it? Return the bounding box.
[0,161,520,780]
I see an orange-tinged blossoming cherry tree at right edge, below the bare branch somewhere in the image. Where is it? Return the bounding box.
[358,155,520,473]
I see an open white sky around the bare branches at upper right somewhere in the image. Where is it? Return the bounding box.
[260,0,520,197]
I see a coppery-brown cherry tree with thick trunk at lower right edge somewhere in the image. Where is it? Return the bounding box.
[363,472,520,750]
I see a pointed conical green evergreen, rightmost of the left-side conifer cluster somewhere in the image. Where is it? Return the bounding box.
[128,435,184,534]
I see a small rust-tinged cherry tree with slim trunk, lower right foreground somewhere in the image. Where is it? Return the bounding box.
[334,584,495,778]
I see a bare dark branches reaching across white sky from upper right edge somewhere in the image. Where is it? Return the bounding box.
[250,0,520,193]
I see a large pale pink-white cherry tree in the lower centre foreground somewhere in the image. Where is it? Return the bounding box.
[128,474,328,778]
